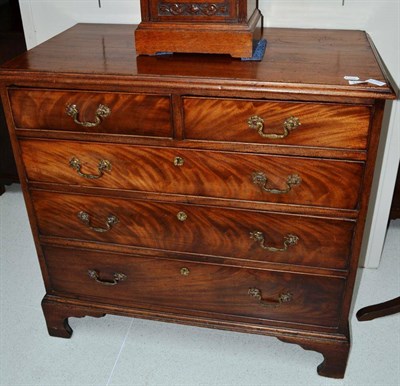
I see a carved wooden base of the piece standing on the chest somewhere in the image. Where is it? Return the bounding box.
[135,0,262,58]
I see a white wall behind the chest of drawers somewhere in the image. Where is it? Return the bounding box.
[20,0,400,267]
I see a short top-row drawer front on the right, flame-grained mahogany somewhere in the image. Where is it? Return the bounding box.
[183,98,371,150]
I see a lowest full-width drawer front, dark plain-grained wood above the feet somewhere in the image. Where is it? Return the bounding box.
[44,247,345,328]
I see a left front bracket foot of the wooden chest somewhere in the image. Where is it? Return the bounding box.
[42,296,105,338]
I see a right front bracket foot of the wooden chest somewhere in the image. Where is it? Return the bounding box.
[279,337,350,378]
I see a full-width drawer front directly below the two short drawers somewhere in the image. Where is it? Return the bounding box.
[20,140,363,209]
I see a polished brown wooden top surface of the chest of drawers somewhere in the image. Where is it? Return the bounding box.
[1,24,395,99]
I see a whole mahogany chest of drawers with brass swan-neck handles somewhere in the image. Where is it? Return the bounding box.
[0,25,395,378]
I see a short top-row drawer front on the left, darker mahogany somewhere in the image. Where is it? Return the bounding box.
[9,89,172,137]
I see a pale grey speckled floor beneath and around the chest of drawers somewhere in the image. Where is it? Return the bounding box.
[0,185,400,386]
